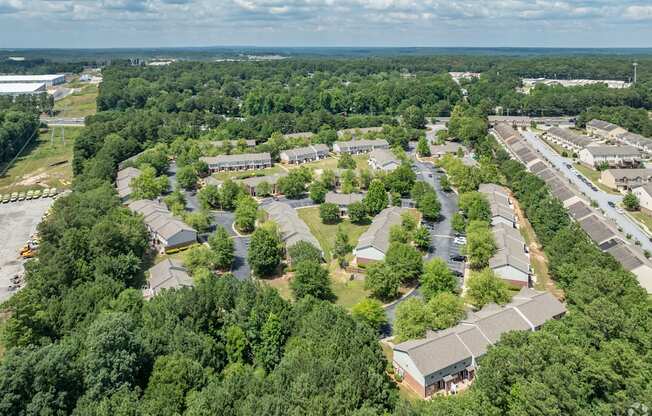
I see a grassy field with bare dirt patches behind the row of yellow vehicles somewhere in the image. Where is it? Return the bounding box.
[0,127,81,194]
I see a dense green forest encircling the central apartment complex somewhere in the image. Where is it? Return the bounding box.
[0,57,652,416]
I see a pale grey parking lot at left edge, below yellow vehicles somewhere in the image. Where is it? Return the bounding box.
[0,198,54,302]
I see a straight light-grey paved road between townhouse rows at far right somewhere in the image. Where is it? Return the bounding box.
[523,131,652,251]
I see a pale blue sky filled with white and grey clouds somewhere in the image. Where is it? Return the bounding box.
[0,0,652,48]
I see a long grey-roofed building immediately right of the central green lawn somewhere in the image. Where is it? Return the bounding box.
[353,207,408,264]
